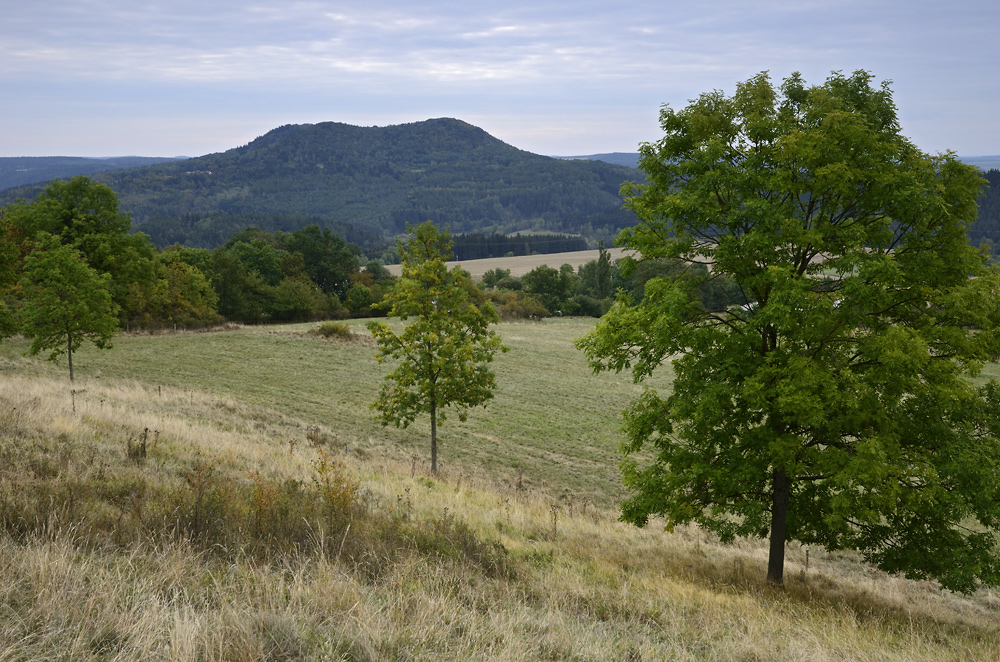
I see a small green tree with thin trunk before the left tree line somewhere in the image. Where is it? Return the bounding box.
[21,233,118,381]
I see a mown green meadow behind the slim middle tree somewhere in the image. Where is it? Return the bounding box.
[0,318,672,506]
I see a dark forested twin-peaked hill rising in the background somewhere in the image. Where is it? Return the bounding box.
[0,119,642,247]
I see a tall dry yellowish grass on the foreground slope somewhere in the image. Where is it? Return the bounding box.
[0,370,1000,661]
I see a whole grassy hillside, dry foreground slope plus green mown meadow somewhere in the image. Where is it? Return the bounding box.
[0,319,1000,661]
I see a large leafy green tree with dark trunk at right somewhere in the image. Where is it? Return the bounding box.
[578,71,1000,590]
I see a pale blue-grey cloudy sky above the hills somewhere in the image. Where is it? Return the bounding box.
[0,0,1000,157]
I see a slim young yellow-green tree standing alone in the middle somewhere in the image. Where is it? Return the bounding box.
[368,221,507,474]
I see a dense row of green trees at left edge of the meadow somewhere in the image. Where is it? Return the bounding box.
[0,176,404,375]
